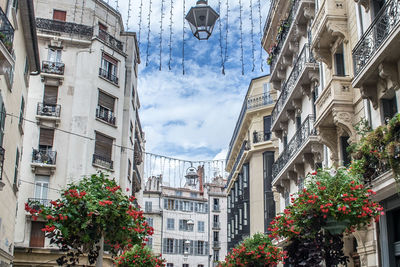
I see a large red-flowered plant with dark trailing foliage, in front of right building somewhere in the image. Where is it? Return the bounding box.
[269,167,383,266]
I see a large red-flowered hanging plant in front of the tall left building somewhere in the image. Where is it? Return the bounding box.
[25,173,153,265]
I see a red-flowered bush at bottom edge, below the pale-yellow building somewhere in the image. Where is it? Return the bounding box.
[218,233,286,267]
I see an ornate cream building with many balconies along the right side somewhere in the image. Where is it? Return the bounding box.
[262,0,400,266]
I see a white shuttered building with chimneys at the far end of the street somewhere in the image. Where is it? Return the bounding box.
[143,166,227,267]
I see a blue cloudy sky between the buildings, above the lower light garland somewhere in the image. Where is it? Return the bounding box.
[115,0,269,160]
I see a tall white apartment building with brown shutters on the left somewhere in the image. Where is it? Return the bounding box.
[14,0,144,266]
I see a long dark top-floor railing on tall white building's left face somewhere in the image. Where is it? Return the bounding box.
[36,18,93,38]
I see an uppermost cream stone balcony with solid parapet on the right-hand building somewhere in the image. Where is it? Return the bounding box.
[311,0,348,69]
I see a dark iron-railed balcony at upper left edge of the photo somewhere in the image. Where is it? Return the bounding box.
[0,8,14,70]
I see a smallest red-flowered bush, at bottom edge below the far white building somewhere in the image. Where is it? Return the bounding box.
[115,245,165,267]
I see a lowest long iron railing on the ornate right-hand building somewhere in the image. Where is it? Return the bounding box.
[272,115,317,179]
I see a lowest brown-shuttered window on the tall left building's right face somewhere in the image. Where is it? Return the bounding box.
[93,132,114,169]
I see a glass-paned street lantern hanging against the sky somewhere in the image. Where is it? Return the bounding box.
[186,0,219,40]
